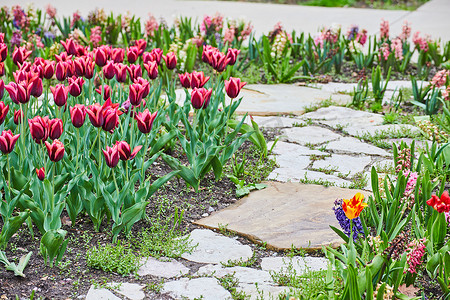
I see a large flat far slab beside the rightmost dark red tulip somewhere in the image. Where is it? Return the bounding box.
[232,84,351,115]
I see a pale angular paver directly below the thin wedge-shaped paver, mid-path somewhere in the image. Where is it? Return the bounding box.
[313,154,372,177]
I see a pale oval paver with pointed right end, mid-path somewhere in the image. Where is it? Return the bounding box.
[281,126,341,146]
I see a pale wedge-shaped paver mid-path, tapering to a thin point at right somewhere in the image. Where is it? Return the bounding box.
[325,137,391,156]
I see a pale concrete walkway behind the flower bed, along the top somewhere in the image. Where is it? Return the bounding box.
[2,0,450,41]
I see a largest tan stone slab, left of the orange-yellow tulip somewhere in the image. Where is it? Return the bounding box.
[195,182,368,250]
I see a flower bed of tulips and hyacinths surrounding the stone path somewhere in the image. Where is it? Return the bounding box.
[0,6,450,299]
